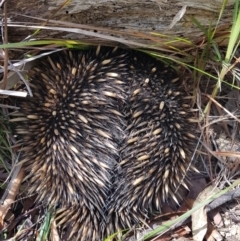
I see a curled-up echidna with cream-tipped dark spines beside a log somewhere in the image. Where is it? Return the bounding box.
[12,47,195,241]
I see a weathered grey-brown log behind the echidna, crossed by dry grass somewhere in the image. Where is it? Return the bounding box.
[7,0,235,43]
